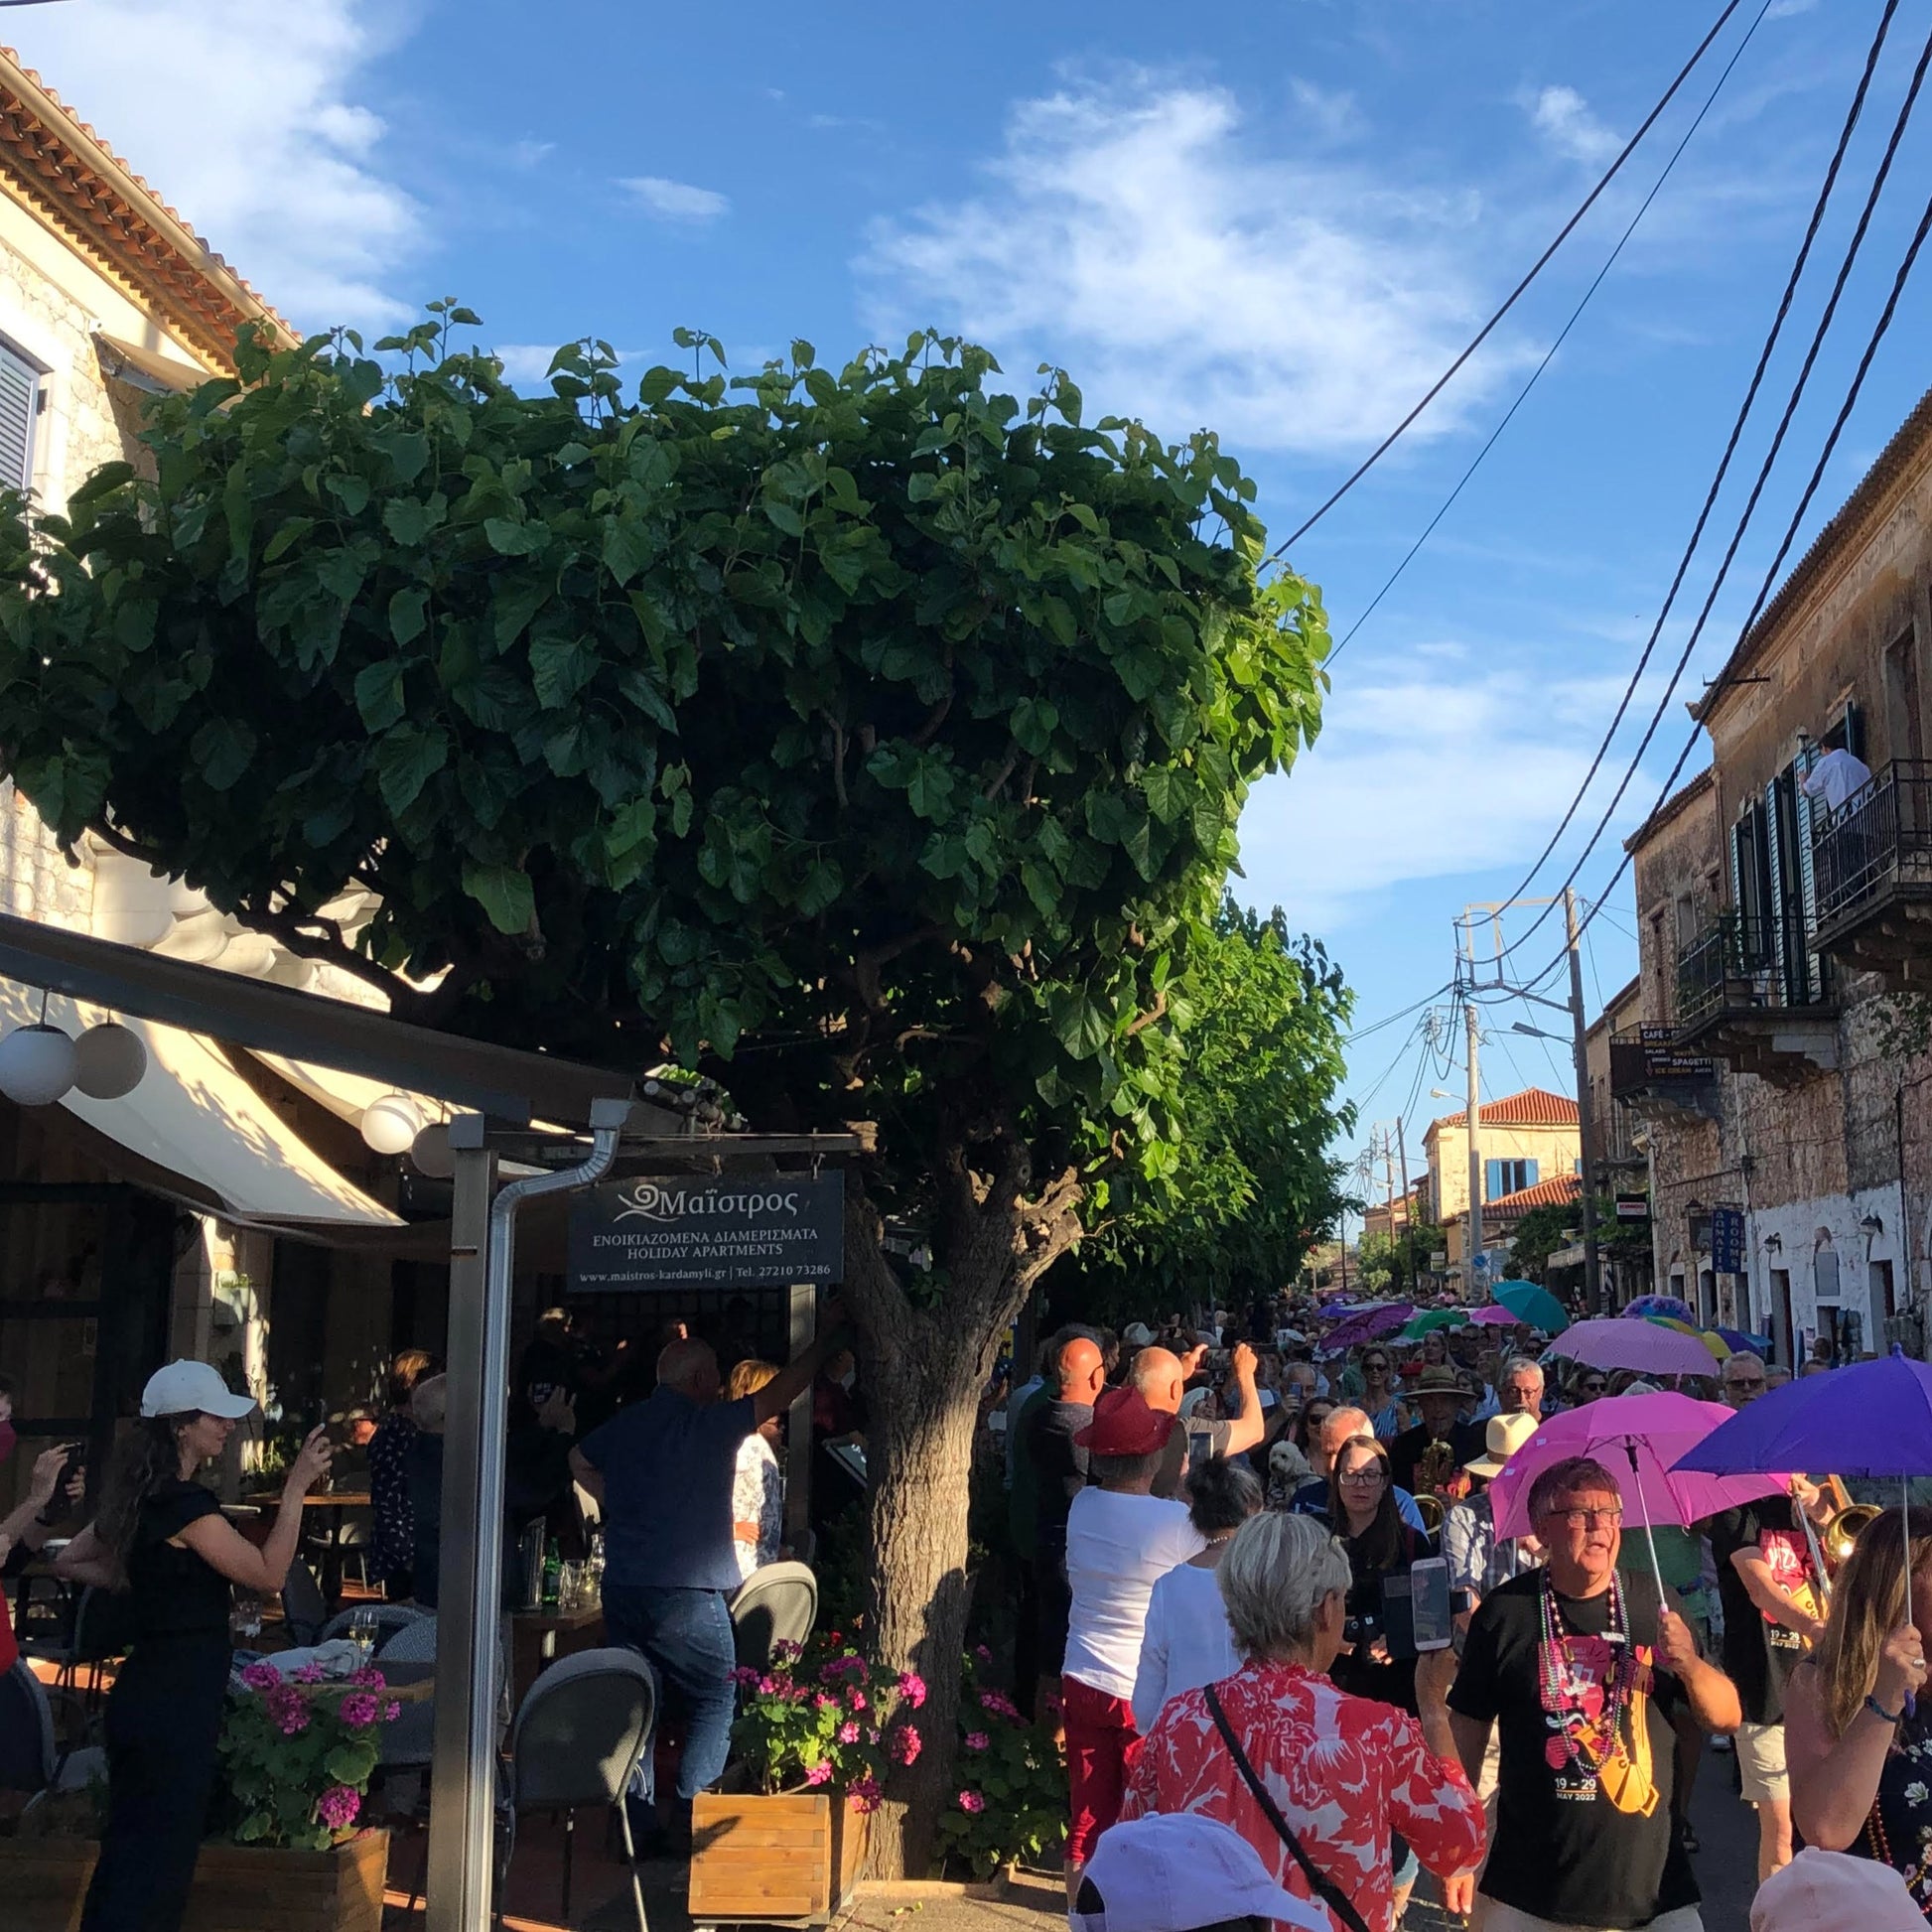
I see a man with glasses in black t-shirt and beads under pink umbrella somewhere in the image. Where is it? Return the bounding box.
[1449,1456,1740,1932]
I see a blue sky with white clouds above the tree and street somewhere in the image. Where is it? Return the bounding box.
[6,0,1932,1197]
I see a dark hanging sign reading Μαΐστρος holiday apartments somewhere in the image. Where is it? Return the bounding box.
[570,1171,844,1295]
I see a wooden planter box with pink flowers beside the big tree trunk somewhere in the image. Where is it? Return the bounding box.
[690,1791,868,1926]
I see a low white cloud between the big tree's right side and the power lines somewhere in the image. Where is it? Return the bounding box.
[1240,668,1664,931]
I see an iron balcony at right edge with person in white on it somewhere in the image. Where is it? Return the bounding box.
[1812,758,1932,993]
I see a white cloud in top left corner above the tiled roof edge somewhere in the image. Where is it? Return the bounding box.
[8,0,423,331]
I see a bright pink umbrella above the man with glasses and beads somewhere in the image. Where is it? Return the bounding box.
[1489,1398,1791,1590]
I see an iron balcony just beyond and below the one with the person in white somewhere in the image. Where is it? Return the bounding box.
[1675,912,1838,1086]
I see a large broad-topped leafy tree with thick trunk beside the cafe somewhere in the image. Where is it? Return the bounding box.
[0,302,1327,1868]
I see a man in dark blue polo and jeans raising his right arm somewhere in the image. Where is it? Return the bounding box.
[570,1321,837,1814]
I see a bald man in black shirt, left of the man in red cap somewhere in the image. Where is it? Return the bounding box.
[1013,1327,1107,1712]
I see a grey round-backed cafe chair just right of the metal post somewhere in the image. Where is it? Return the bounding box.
[496,1646,657,1932]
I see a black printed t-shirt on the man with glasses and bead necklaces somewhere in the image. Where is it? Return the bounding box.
[1449,1571,1699,1932]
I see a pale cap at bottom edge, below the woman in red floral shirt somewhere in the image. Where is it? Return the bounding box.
[1066,1812,1329,1932]
